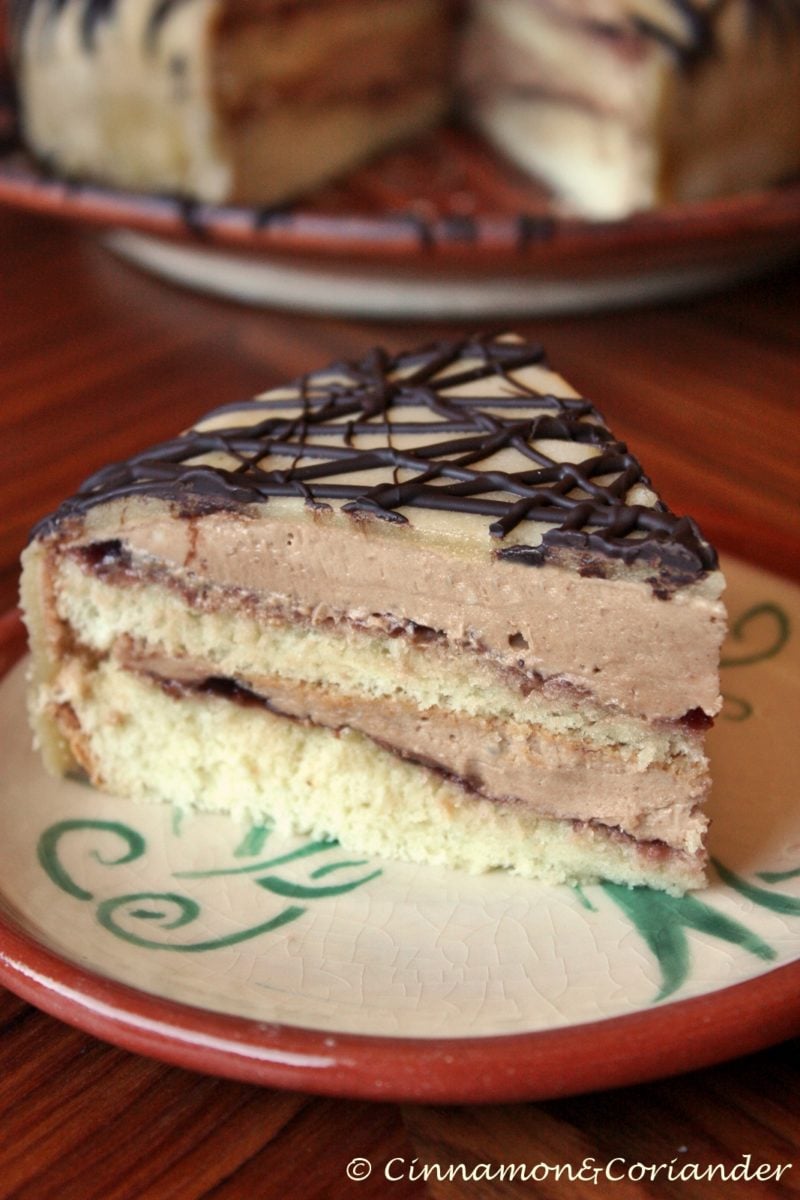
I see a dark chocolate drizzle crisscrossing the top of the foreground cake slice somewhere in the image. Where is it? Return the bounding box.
[35,336,716,596]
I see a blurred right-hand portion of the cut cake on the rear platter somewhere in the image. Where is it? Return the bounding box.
[463,0,800,218]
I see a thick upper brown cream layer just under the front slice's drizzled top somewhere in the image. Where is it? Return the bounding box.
[53,499,724,720]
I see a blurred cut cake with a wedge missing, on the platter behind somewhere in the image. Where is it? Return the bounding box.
[11,0,800,218]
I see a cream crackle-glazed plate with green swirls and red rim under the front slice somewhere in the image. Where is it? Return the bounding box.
[0,552,800,1102]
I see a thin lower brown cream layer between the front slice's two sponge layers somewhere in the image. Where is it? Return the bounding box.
[131,653,706,853]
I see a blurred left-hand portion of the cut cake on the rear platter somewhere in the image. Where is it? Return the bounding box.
[11,0,452,205]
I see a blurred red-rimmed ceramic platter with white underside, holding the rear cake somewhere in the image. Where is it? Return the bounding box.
[0,87,800,318]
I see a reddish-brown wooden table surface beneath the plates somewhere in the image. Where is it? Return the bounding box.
[0,201,800,1200]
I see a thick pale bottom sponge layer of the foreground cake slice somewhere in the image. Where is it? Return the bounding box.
[43,660,704,894]
